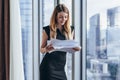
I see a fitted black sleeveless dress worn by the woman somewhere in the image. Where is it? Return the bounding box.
[40,26,67,80]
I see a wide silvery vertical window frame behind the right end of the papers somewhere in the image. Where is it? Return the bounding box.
[72,0,84,80]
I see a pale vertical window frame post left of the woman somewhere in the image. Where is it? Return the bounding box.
[32,0,41,80]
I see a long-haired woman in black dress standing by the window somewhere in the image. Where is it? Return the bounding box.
[40,4,80,80]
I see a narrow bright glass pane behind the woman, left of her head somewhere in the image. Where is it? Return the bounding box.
[40,0,54,63]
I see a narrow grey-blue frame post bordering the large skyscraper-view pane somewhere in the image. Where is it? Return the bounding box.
[81,0,87,80]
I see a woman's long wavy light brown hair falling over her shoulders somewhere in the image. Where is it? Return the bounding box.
[50,4,71,39]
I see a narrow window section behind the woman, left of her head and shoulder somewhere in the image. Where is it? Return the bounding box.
[40,0,54,62]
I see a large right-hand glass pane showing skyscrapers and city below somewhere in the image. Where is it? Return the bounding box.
[86,0,120,80]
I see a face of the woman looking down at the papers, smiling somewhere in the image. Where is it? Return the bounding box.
[57,12,68,26]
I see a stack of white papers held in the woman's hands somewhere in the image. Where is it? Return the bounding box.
[48,39,80,53]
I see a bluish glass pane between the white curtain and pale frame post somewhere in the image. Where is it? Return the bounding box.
[20,0,33,80]
